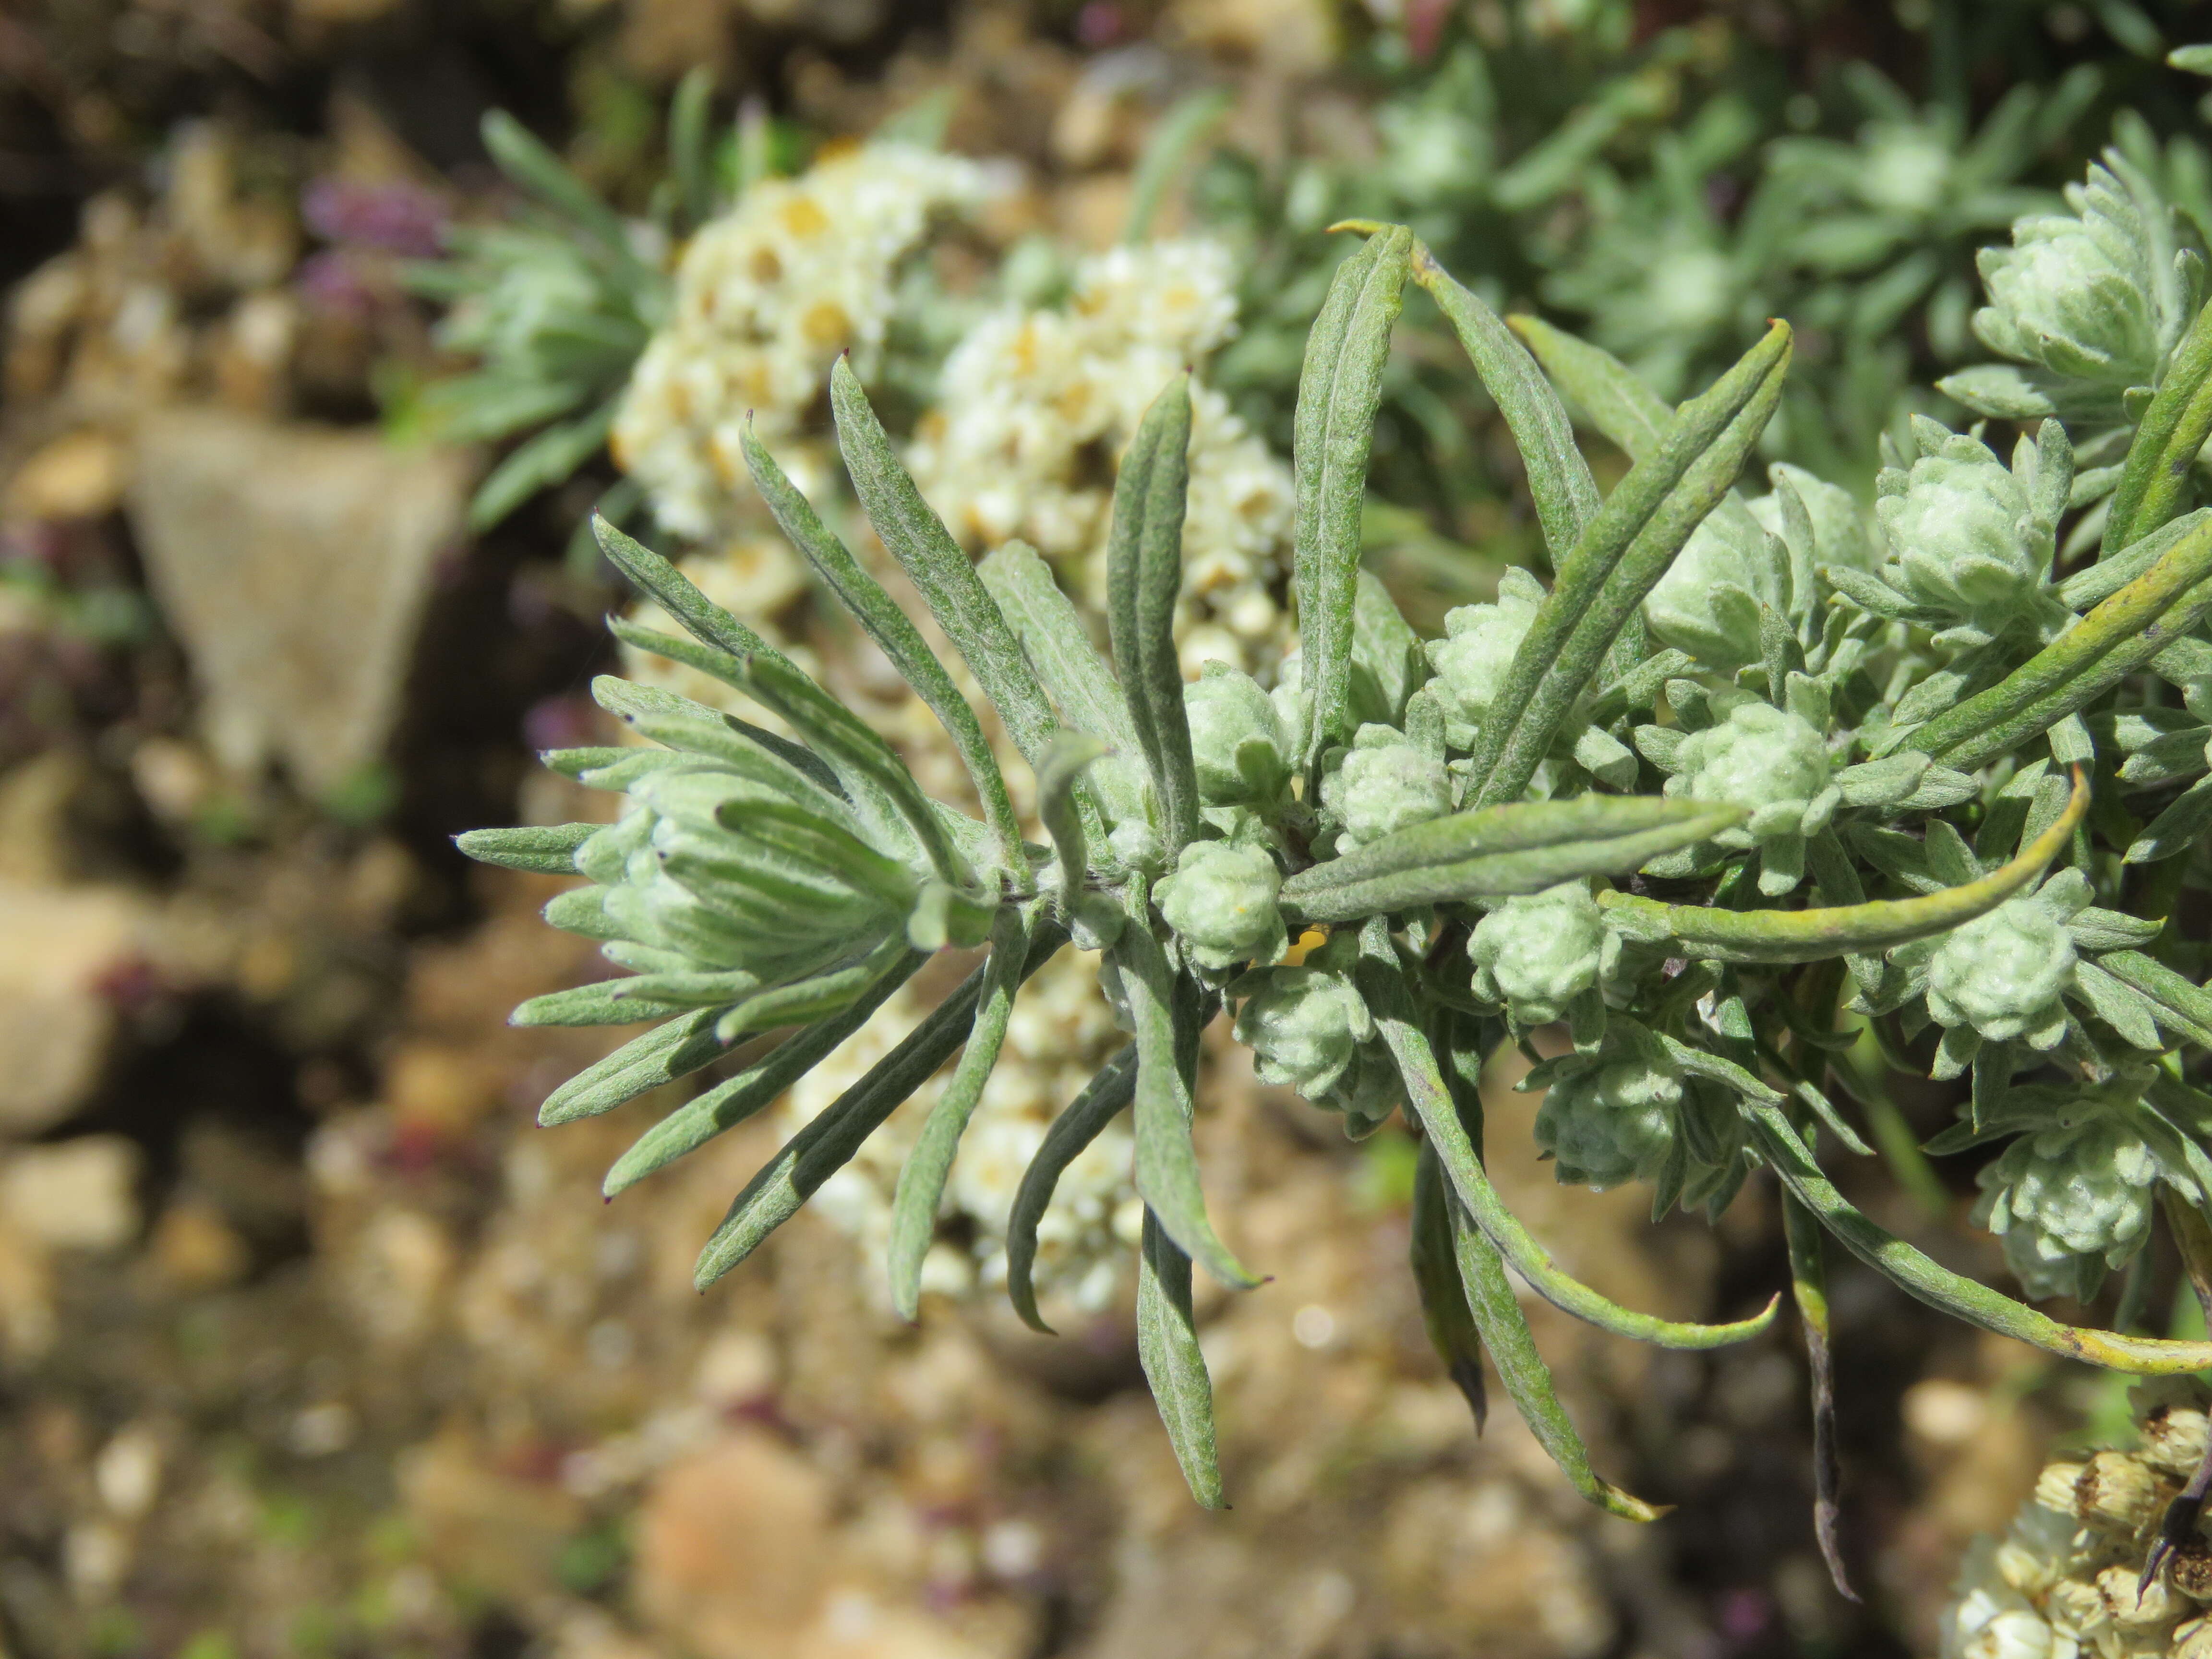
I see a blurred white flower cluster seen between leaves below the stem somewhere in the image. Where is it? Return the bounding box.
[781,951,1143,1314]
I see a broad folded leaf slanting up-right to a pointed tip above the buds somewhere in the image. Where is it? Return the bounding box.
[1467,323,1790,805]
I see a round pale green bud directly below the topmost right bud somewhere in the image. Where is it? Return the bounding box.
[1874,436,2051,622]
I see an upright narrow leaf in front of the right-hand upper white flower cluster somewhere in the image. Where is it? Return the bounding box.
[1106,374,1199,852]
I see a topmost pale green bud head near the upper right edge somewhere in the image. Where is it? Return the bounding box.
[1973,164,2161,389]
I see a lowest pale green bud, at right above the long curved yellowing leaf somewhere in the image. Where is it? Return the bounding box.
[1973,1097,2159,1301]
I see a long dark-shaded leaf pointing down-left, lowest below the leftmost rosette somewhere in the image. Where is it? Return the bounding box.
[692,923,1069,1289]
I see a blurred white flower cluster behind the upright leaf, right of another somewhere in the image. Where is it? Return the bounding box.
[907,241,1292,673]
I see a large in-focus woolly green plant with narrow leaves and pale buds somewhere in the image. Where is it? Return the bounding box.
[462,198,2212,1601]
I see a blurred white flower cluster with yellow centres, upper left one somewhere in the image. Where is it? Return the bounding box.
[611,144,993,540]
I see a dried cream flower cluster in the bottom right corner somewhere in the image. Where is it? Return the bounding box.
[1942,1378,2212,1659]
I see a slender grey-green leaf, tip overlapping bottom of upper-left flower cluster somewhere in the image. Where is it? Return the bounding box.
[743,418,1022,869]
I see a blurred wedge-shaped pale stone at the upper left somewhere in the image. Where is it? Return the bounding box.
[128,409,469,794]
